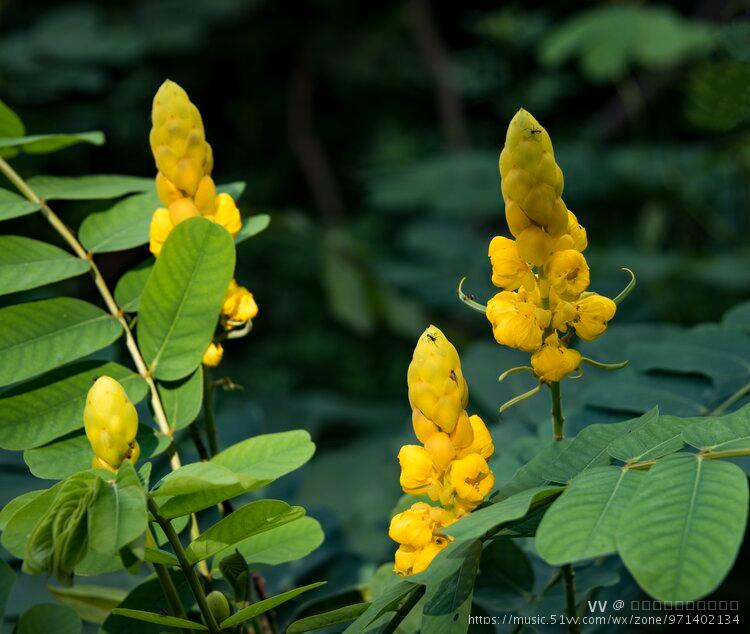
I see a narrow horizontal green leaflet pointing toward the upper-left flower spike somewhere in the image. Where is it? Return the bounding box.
[27,174,154,200]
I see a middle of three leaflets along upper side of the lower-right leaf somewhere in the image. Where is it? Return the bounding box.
[607,416,690,462]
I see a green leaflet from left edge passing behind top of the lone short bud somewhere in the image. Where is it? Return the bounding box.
[0,361,148,450]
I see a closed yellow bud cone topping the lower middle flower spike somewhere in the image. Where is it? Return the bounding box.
[407,326,469,433]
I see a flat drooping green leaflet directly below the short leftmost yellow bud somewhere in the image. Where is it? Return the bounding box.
[89,460,148,554]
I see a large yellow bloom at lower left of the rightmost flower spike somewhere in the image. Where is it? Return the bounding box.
[487,288,551,352]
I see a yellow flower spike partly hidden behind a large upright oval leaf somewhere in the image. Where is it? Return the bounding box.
[149,80,258,366]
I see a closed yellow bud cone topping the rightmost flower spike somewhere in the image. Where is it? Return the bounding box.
[500,109,567,237]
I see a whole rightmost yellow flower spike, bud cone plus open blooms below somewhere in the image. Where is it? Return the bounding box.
[486,110,616,383]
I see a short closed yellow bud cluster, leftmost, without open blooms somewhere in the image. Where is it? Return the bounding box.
[83,376,140,471]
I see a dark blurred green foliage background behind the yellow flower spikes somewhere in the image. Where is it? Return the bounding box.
[0,0,750,618]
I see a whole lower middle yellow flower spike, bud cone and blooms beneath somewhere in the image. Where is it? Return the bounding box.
[389,326,495,575]
